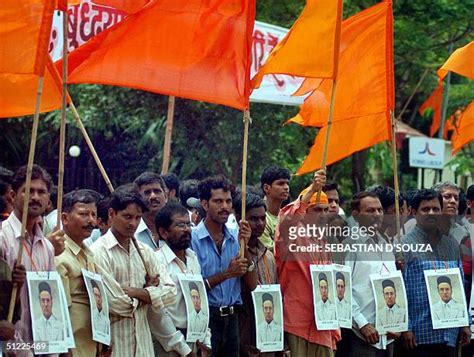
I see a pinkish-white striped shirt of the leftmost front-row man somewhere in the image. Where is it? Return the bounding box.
[0,213,55,342]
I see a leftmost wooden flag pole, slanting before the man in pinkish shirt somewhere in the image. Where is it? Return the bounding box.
[7,76,44,322]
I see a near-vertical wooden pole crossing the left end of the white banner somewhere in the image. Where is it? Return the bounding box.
[56,8,68,229]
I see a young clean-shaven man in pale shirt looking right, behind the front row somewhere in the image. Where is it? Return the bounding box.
[260,166,291,252]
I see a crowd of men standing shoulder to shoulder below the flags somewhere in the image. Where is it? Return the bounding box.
[0,165,474,357]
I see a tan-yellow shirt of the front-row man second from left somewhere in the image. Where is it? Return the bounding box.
[55,236,98,357]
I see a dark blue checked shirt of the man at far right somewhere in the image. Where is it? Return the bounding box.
[402,226,464,347]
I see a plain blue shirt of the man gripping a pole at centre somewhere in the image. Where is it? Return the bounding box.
[191,221,242,307]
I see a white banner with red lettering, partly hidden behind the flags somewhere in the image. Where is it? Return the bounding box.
[49,0,305,105]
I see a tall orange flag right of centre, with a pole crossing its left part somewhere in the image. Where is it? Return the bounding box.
[291,2,394,174]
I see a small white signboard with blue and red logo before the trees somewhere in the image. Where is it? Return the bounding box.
[409,137,445,169]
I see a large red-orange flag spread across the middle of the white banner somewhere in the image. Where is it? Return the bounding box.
[65,0,255,109]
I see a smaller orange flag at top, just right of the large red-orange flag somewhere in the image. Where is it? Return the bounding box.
[252,0,342,88]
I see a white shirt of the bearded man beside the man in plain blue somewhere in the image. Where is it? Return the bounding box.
[148,241,211,356]
